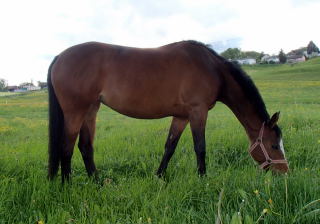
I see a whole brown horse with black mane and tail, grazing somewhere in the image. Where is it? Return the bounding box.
[48,41,288,181]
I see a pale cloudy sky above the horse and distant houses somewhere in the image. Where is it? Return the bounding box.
[0,0,320,85]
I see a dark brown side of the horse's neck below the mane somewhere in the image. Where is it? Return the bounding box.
[222,80,263,141]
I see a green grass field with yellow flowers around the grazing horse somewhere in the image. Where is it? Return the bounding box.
[0,58,320,224]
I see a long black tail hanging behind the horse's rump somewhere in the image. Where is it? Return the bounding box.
[47,56,64,179]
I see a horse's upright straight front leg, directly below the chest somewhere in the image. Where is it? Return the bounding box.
[189,107,208,176]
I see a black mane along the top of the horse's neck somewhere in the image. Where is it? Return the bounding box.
[188,40,270,121]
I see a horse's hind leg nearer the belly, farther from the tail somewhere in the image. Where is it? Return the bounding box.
[78,103,100,176]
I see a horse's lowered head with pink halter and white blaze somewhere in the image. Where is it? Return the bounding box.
[249,112,289,173]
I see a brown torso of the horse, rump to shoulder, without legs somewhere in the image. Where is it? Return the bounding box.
[52,42,220,118]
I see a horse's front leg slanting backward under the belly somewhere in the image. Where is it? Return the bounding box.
[157,117,188,177]
